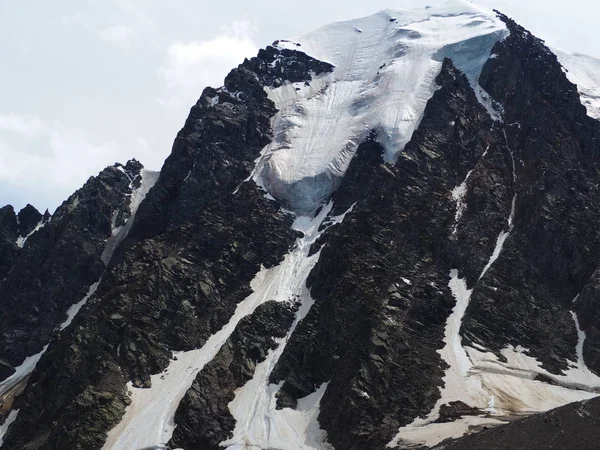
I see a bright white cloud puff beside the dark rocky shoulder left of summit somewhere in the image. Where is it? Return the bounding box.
[160,20,258,108]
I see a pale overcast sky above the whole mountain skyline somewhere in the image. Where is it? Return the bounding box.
[0,0,600,212]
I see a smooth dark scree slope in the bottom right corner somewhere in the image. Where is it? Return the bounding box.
[434,398,600,450]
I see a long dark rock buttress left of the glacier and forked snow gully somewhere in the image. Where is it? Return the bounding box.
[4,46,331,450]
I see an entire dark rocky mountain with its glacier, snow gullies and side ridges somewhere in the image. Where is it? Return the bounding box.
[0,1,600,450]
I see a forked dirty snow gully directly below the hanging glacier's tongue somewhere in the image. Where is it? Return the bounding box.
[102,204,341,450]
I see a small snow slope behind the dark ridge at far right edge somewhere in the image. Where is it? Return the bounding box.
[552,48,600,120]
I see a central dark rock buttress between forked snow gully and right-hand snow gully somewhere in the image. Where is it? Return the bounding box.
[271,60,512,449]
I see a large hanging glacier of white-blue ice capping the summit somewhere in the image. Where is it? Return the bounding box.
[254,0,508,213]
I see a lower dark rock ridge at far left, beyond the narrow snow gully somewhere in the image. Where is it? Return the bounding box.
[0,161,142,372]
